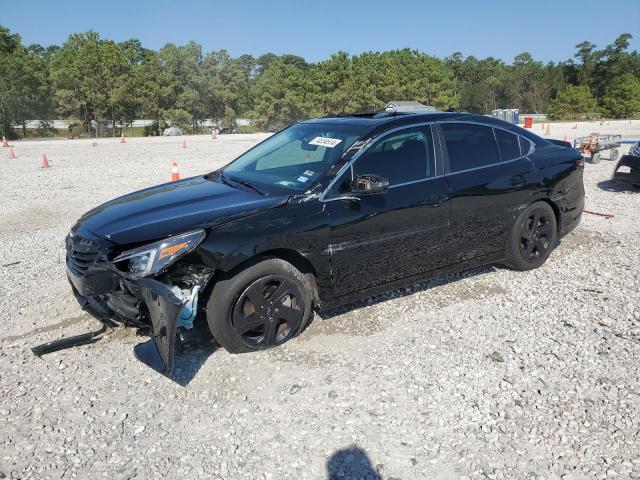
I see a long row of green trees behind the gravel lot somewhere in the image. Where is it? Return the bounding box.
[0,26,640,136]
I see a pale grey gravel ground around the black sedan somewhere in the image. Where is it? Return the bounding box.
[0,122,640,480]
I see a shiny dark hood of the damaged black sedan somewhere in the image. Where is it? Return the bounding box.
[73,176,288,245]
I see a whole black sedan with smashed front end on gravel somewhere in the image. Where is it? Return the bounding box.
[58,112,584,373]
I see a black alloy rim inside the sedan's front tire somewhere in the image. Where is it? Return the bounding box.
[231,275,304,350]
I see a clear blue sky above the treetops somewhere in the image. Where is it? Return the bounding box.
[5,0,640,62]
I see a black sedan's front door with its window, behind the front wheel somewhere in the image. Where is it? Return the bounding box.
[325,126,450,296]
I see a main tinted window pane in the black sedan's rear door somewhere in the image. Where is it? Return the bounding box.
[440,123,500,172]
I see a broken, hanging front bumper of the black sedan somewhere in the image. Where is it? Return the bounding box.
[32,236,213,376]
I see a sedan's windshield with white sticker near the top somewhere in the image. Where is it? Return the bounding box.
[222,123,367,193]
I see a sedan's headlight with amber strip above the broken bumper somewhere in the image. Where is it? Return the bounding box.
[113,230,206,277]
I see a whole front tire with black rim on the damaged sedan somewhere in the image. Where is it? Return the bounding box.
[207,258,313,353]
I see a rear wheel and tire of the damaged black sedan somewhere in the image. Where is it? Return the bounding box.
[507,202,558,271]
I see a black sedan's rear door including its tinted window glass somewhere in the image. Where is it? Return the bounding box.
[439,122,533,263]
